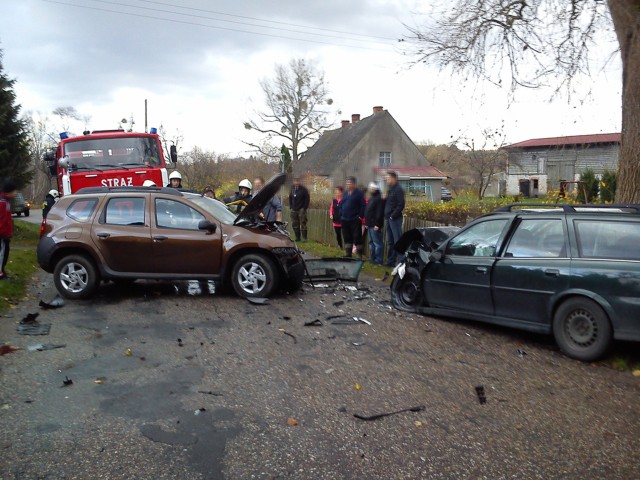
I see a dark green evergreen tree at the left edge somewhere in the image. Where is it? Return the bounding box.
[0,50,33,189]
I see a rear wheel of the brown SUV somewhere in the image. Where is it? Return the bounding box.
[53,255,99,299]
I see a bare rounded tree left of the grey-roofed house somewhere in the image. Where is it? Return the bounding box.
[244,59,333,166]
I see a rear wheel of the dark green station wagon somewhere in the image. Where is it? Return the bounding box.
[553,297,612,362]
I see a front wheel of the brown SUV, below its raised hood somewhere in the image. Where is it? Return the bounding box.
[231,253,276,297]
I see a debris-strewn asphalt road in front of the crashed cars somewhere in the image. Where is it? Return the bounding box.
[0,273,640,479]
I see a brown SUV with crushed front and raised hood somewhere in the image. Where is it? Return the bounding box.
[38,174,304,299]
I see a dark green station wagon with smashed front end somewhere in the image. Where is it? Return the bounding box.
[392,204,640,361]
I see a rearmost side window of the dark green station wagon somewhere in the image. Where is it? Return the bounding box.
[574,220,640,260]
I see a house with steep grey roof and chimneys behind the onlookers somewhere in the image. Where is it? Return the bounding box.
[293,106,447,202]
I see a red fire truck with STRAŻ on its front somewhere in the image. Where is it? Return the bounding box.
[43,128,178,195]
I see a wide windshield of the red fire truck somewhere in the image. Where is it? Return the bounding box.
[64,137,163,171]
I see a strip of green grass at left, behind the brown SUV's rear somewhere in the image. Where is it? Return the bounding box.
[0,221,40,313]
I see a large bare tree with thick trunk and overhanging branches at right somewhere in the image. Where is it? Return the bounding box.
[404,0,640,203]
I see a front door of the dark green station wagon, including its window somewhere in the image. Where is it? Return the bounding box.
[425,218,511,315]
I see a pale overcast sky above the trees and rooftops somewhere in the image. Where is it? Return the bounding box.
[0,0,621,155]
